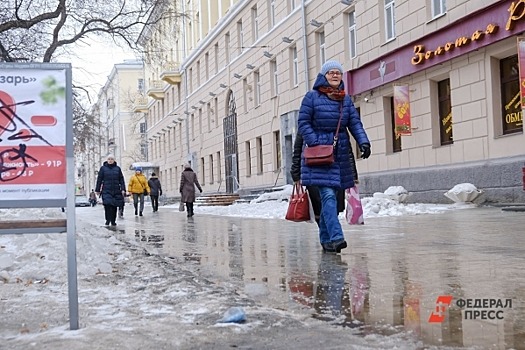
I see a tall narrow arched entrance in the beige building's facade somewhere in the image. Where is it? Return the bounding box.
[223,90,239,193]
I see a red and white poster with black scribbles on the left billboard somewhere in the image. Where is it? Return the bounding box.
[0,68,67,200]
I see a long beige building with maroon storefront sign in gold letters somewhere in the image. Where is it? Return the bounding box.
[134,0,525,202]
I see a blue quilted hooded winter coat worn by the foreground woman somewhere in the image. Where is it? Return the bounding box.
[298,74,370,189]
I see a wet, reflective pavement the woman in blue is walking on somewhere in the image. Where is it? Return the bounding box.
[81,207,525,349]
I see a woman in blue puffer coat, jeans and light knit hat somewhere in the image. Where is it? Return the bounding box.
[298,61,370,253]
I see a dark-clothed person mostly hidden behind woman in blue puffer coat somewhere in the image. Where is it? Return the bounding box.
[290,133,358,230]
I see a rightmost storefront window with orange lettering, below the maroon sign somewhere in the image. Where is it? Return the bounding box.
[500,55,523,135]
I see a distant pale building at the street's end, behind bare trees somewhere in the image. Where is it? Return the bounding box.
[82,60,147,193]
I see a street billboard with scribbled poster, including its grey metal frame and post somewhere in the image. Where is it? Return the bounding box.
[0,62,79,330]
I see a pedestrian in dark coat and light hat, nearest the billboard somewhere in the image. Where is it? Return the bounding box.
[95,154,126,226]
